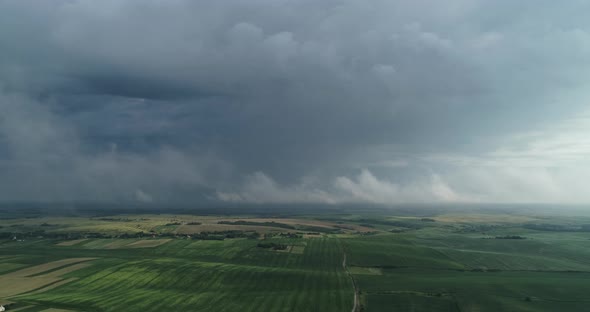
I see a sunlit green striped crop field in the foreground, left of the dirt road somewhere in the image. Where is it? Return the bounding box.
[0,238,353,311]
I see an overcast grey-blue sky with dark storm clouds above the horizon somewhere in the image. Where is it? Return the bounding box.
[0,0,590,204]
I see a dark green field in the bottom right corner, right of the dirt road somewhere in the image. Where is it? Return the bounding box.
[356,269,590,311]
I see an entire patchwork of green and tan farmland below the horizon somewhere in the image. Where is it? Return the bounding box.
[0,207,590,312]
